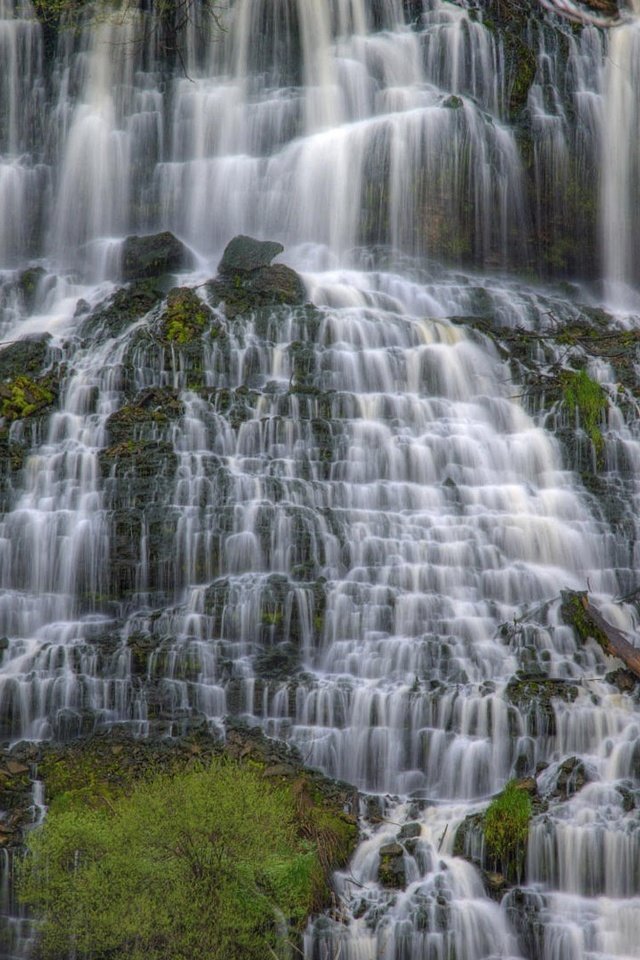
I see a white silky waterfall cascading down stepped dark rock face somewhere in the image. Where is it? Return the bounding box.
[0,0,640,960]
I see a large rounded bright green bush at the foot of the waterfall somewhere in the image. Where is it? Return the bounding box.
[19,758,324,960]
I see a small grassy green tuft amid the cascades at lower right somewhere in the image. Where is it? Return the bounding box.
[483,780,531,874]
